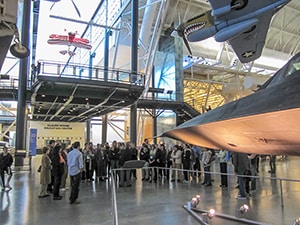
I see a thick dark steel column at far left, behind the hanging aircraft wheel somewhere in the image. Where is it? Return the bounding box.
[15,0,31,166]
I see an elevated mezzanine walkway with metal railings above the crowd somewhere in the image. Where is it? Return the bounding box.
[0,61,199,122]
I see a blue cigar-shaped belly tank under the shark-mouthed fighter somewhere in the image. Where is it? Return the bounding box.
[215,19,258,42]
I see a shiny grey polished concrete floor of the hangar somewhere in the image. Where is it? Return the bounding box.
[0,156,300,225]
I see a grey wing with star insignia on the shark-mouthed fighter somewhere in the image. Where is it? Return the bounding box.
[228,12,273,63]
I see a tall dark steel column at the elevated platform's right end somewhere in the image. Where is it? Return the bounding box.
[130,0,139,144]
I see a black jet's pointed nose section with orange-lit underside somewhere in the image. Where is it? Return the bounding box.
[162,53,300,155]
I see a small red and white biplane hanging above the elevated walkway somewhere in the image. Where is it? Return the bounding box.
[47,32,92,56]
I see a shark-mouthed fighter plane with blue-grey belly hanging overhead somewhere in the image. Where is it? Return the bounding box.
[172,0,290,63]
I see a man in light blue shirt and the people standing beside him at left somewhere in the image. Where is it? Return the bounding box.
[39,140,83,204]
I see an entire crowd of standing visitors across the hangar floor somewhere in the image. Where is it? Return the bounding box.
[0,139,282,201]
